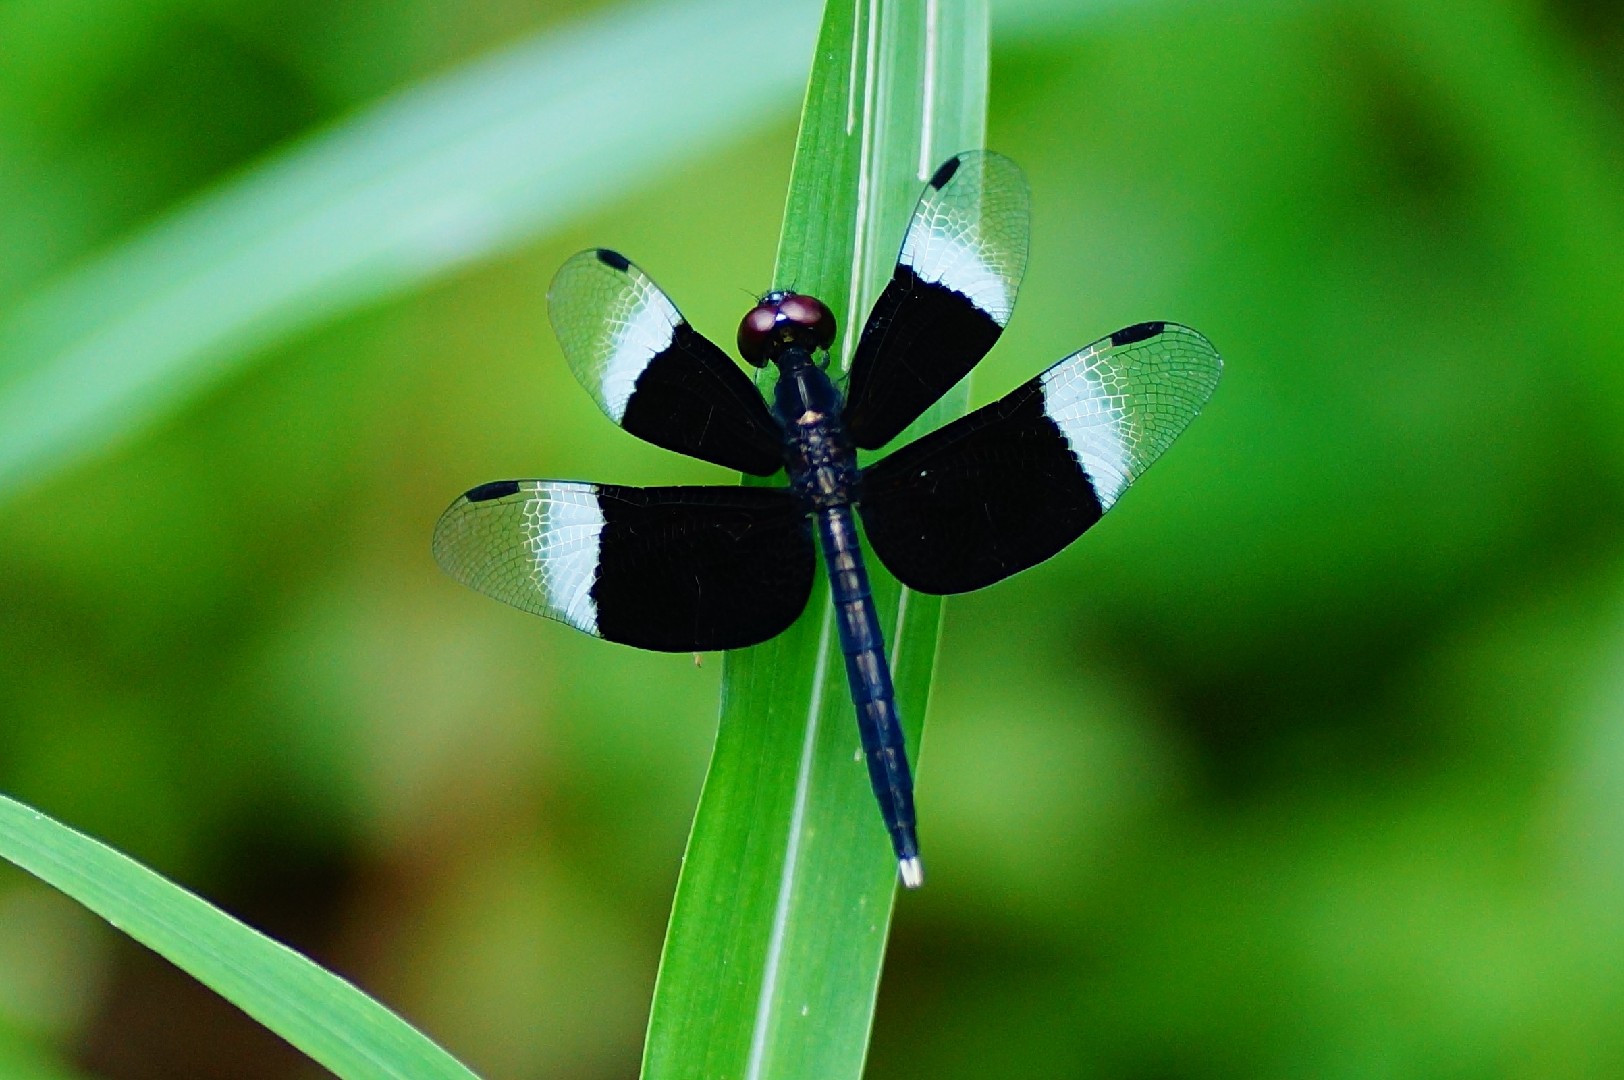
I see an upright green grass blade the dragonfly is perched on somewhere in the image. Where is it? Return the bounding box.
[643,0,987,1080]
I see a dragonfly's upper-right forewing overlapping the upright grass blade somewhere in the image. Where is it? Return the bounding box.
[844,151,1031,450]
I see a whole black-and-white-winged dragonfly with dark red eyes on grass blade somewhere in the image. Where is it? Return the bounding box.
[434,151,1221,887]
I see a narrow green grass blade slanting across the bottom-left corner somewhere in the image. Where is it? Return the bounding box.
[0,796,474,1080]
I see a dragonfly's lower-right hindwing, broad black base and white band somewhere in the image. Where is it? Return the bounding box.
[861,323,1223,593]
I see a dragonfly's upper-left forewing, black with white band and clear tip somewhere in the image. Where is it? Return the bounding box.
[547,248,783,476]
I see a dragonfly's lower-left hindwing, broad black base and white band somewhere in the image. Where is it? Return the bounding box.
[434,481,814,653]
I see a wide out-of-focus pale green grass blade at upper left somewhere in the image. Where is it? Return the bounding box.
[0,0,815,497]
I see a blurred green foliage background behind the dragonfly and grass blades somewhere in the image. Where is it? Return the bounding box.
[0,0,1624,1080]
